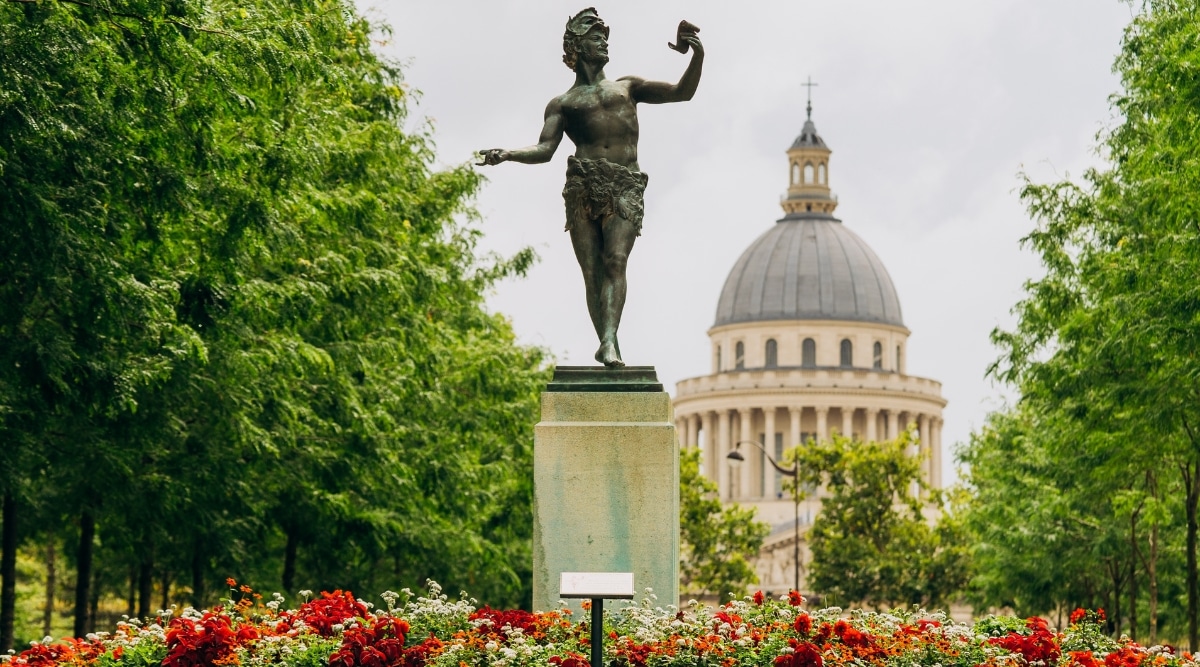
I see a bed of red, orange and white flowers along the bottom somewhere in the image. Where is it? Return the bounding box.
[6,581,1200,667]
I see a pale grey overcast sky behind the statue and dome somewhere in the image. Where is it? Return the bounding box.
[360,0,1132,474]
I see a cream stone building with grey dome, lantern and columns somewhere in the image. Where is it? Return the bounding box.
[674,104,946,593]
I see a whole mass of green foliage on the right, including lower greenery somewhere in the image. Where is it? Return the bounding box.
[965,0,1200,648]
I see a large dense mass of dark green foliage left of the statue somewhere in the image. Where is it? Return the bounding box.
[0,0,546,647]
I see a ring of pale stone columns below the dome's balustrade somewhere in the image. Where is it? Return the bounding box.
[676,405,942,500]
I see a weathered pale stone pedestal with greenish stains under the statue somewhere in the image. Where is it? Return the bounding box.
[533,366,679,618]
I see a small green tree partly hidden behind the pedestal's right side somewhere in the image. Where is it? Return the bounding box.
[679,449,770,601]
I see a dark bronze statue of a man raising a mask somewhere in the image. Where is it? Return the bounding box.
[479,7,704,367]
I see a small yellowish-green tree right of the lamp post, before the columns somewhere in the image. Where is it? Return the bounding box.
[788,432,967,607]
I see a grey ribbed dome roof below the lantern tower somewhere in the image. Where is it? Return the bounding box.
[714,212,904,326]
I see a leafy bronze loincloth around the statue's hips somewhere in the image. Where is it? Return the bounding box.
[563,155,649,236]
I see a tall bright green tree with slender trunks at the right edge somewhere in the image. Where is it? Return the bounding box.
[994,0,1200,649]
